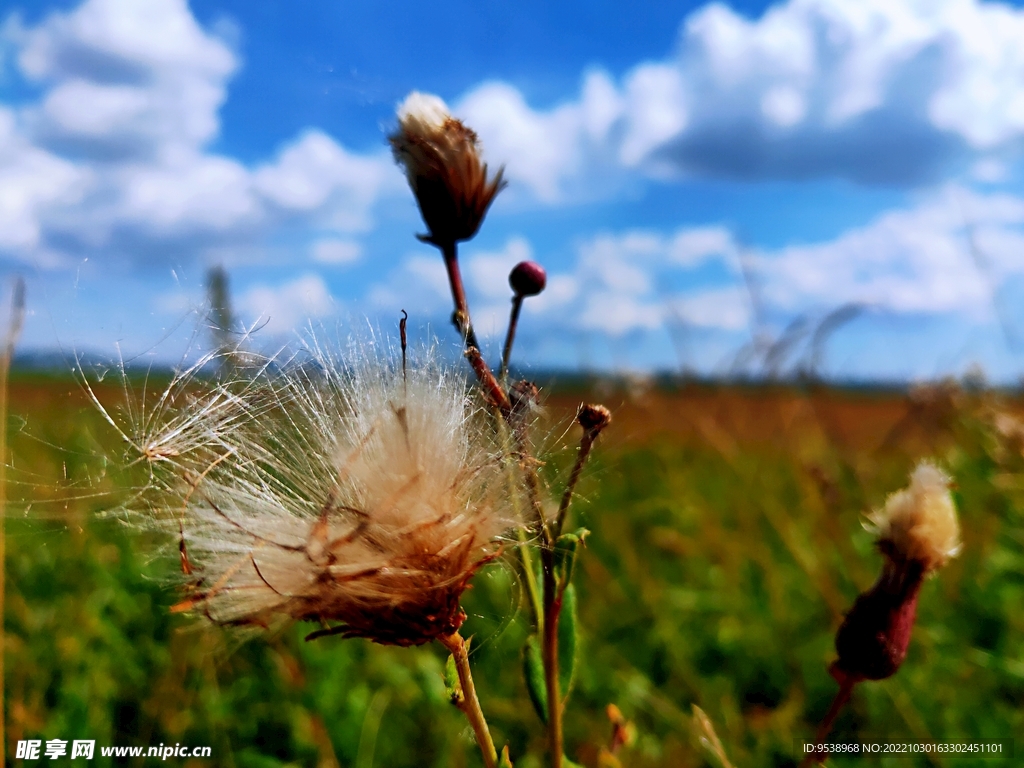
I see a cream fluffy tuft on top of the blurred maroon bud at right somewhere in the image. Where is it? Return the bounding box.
[868,461,961,573]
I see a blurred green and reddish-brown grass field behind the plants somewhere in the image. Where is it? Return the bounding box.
[4,376,1024,768]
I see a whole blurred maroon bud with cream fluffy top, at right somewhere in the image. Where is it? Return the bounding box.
[833,462,961,682]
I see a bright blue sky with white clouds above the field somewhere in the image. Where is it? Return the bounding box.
[0,0,1024,381]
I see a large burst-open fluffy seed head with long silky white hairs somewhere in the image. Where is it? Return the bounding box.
[123,342,513,645]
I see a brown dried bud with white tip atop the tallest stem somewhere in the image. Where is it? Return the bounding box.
[390,91,505,246]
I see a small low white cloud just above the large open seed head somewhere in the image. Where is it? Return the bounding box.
[238,274,337,336]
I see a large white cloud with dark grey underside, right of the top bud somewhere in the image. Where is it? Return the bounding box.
[450,0,1024,195]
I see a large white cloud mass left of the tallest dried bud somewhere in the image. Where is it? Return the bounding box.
[0,0,400,266]
